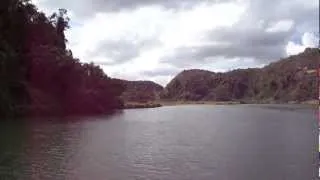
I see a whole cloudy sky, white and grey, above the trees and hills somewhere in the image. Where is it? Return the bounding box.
[33,0,319,85]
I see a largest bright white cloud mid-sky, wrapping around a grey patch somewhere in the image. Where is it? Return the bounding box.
[62,3,245,85]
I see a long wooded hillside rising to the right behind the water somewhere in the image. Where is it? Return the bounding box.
[161,48,320,102]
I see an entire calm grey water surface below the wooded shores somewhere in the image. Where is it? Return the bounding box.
[0,105,318,180]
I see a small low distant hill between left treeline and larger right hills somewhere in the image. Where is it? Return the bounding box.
[116,80,163,103]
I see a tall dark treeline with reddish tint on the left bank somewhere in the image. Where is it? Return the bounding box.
[0,0,124,117]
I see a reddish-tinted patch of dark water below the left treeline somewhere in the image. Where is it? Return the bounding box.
[24,121,82,179]
